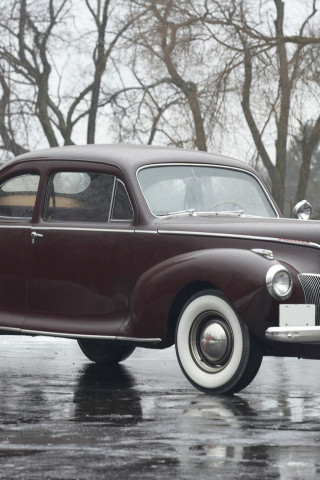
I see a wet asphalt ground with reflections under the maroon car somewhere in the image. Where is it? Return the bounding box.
[0,337,320,480]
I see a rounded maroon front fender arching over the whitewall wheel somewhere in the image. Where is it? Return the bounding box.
[131,249,284,339]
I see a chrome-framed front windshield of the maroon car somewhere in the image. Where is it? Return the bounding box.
[138,165,277,217]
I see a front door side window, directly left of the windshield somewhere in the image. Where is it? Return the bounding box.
[44,172,115,222]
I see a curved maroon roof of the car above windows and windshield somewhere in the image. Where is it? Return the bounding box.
[6,144,255,173]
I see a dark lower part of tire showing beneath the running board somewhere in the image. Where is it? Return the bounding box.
[78,339,135,365]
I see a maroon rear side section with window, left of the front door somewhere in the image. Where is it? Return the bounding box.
[0,167,40,331]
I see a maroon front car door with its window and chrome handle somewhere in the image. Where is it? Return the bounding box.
[23,163,134,336]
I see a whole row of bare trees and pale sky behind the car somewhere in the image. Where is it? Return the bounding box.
[0,0,320,213]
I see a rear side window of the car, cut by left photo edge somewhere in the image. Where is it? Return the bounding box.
[0,174,40,219]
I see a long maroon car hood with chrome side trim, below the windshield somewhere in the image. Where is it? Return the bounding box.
[158,215,320,248]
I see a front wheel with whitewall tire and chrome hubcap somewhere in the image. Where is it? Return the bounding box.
[176,290,263,394]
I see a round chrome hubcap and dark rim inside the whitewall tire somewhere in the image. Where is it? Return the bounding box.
[189,312,233,373]
